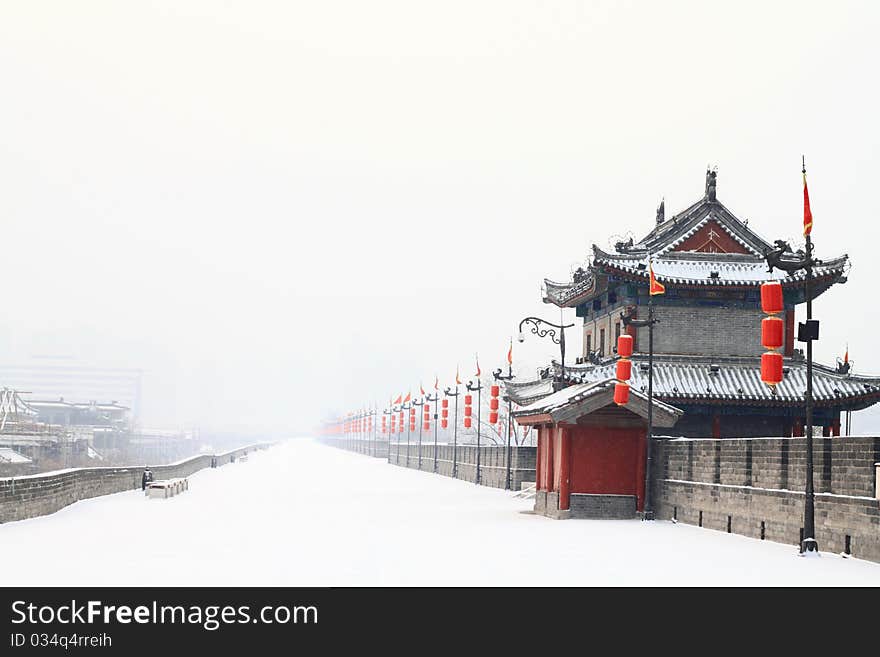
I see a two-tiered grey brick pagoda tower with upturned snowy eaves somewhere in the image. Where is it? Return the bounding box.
[507,171,880,438]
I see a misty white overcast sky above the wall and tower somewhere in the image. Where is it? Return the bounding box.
[0,0,880,430]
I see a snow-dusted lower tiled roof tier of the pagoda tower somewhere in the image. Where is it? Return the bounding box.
[508,354,880,410]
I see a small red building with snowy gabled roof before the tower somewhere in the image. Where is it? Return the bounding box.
[514,379,683,518]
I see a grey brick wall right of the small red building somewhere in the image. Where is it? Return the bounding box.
[653,437,880,561]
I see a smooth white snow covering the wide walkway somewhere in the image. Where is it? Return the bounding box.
[0,439,880,586]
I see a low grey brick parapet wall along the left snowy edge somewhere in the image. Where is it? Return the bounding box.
[0,443,269,523]
